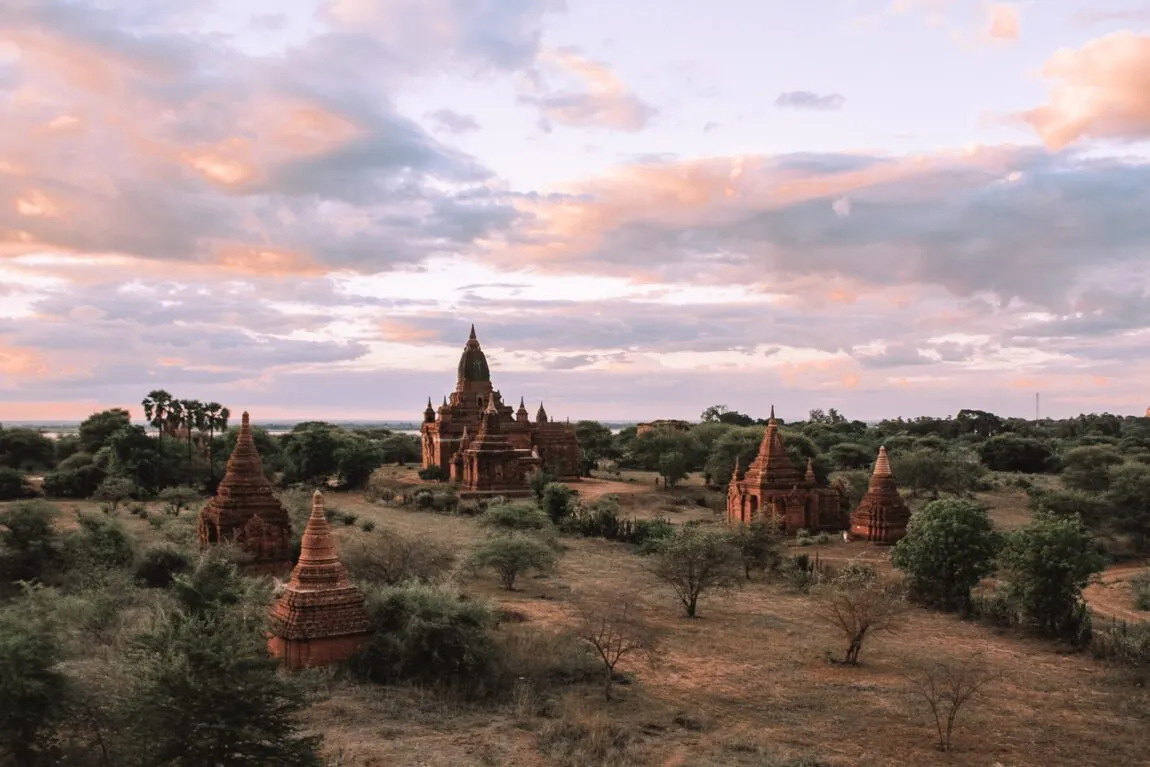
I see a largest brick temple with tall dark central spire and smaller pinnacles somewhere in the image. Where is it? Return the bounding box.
[420,325,581,485]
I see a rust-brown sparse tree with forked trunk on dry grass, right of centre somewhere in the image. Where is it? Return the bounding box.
[813,567,906,666]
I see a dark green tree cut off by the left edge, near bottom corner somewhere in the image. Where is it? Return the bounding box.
[0,586,69,767]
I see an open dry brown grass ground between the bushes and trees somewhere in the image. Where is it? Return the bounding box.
[2,468,1150,767]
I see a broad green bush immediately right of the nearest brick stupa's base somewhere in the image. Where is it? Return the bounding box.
[348,583,499,697]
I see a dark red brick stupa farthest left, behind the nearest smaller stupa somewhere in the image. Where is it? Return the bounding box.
[199,413,292,575]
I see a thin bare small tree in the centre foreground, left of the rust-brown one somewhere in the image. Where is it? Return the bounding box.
[575,593,659,700]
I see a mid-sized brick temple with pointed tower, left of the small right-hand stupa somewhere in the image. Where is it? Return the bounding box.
[727,407,850,532]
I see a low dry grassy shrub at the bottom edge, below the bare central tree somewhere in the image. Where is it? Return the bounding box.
[537,697,647,767]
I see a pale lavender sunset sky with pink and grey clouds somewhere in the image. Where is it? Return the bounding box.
[0,0,1150,421]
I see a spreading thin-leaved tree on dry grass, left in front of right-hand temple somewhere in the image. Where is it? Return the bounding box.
[650,526,743,618]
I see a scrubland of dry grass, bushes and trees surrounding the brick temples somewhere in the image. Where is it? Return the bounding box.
[0,400,1150,767]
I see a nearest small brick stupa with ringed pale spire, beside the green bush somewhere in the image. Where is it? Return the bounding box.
[268,490,371,669]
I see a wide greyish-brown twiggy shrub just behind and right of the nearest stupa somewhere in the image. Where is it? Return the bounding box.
[339,528,455,585]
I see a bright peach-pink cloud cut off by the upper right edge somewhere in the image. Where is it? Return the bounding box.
[1022,32,1150,149]
